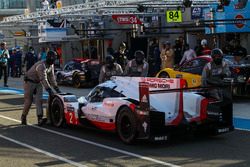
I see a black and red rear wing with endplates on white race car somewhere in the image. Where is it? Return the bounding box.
[137,79,233,140]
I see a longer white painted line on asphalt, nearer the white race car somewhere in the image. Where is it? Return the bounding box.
[0,115,180,167]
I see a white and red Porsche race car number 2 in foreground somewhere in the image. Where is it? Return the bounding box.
[49,77,234,143]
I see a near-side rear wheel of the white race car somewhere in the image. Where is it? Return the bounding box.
[116,107,137,144]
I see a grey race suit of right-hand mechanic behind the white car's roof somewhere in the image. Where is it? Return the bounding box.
[124,59,148,77]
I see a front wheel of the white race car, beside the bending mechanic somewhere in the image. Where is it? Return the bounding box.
[50,97,65,127]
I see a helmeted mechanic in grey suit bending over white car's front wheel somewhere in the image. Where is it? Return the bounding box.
[21,51,61,126]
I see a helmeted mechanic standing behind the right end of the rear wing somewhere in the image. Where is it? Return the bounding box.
[201,48,231,99]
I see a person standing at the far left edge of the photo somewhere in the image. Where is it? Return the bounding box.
[0,42,10,87]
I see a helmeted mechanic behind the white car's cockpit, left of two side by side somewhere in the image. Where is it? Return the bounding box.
[99,55,123,83]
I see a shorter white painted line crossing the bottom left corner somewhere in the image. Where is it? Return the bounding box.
[0,135,87,167]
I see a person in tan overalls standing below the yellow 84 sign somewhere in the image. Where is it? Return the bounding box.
[161,41,174,69]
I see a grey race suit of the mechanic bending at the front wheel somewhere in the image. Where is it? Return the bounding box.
[23,61,57,117]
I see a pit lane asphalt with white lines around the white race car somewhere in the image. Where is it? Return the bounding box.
[0,94,250,167]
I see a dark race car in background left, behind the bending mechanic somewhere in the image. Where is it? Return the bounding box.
[56,58,101,88]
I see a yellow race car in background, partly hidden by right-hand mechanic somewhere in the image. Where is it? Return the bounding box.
[156,55,250,95]
